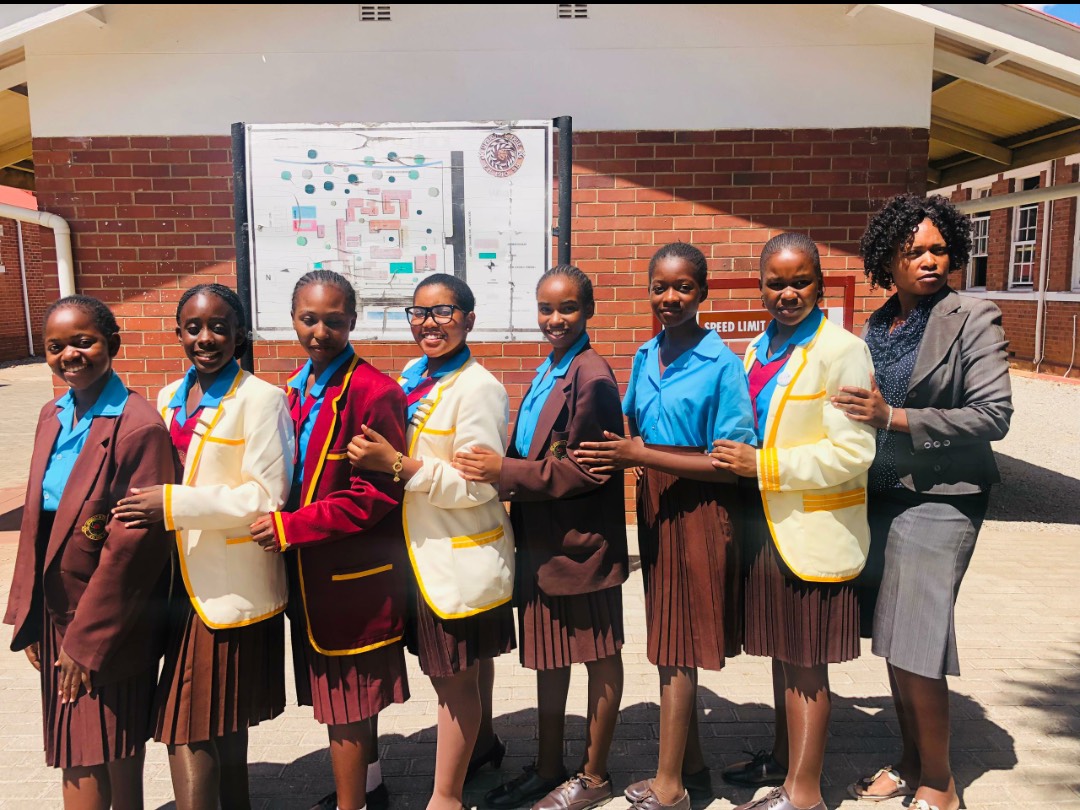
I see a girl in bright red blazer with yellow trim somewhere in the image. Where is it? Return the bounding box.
[252,270,409,810]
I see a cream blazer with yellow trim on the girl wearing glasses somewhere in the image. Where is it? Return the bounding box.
[402,359,514,619]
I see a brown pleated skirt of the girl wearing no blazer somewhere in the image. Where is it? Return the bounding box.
[637,446,742,670]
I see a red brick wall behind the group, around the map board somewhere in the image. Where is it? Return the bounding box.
[35,129,928,511]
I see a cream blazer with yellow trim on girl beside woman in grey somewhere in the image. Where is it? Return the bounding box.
[745,319,876,582]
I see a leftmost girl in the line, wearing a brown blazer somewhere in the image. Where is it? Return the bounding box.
[4,296,176,808]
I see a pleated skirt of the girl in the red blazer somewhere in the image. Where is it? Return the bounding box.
[289,605,409,726]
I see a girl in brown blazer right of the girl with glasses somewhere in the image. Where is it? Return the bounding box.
[455,265,627,810]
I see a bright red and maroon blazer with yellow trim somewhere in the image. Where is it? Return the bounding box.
[274,356,409,656]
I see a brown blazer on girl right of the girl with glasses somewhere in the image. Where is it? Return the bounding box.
[499,343,629,596]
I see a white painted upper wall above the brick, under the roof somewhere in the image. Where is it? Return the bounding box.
[26,3,933,137]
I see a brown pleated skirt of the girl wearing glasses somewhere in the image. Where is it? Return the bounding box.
[405,582,515,678]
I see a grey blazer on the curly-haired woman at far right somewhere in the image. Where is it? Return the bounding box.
[876,289,1013,495]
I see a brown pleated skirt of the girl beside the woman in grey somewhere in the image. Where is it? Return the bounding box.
[740,486,859,666]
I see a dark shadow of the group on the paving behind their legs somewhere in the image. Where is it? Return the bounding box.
[161,688,1015,810]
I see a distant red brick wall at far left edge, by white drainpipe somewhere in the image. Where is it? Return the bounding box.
[0,218,48,361]
